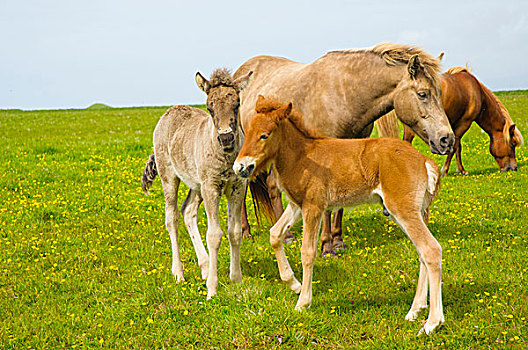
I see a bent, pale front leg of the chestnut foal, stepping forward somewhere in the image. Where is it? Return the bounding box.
[270,202,301,294]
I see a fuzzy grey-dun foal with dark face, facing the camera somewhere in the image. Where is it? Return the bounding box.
[142,69,252,299]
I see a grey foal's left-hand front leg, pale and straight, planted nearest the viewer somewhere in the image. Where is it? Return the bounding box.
[202,183,222,299]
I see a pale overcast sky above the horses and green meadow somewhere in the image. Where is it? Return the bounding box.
[0,0,528,109]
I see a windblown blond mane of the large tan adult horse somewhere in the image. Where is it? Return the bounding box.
[329,42,440,85]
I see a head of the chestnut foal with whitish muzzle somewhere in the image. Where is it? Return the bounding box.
[233,95,292,178]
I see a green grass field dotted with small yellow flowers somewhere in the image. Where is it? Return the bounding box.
[0,91,528,349]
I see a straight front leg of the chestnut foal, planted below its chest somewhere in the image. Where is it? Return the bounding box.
[295,205,323,311]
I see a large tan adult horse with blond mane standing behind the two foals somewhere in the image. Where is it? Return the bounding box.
[234,43,455,255]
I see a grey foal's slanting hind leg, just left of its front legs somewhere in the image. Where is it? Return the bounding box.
[181,189,209,279]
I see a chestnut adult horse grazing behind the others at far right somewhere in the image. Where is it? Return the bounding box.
[377,67,523,175]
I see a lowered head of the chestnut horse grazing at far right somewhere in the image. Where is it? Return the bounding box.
[490,118,523,171]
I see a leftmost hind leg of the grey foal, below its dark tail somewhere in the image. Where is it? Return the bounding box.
[156,163,185,282]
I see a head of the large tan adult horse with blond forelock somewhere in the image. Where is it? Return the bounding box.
[385,49,455,154]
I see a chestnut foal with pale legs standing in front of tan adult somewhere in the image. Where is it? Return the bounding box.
[233,96,444,334]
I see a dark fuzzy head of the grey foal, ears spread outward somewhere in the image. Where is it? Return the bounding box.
[195,68,253,152]
